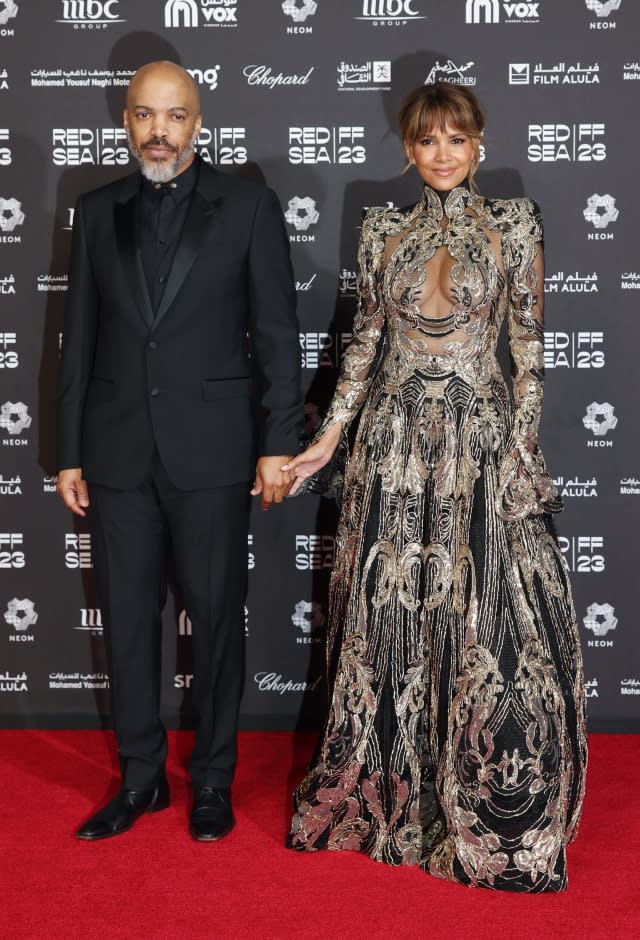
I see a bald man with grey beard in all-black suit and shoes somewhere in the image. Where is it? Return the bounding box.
[57,62,303,841]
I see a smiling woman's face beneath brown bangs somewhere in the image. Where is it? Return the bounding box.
[407,123,478,190]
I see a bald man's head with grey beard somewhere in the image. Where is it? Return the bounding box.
[124,62,202,183]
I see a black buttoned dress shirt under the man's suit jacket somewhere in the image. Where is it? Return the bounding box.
[138,157,199,312]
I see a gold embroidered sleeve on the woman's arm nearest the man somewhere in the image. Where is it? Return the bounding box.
[321,209,384,432]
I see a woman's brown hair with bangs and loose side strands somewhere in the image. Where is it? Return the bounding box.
[398,82,485,189]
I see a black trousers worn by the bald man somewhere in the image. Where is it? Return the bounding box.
[89,455,250,789]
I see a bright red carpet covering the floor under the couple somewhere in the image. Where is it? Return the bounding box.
[0,731,640,940]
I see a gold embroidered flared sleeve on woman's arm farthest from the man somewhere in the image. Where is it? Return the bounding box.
[497,199,562,522]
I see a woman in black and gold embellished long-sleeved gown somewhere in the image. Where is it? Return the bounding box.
[288,84,586,892]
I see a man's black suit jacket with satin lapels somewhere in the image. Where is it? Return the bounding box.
[57,162,303,490]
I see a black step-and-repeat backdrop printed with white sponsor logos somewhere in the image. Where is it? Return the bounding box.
[0,0,640,730]
